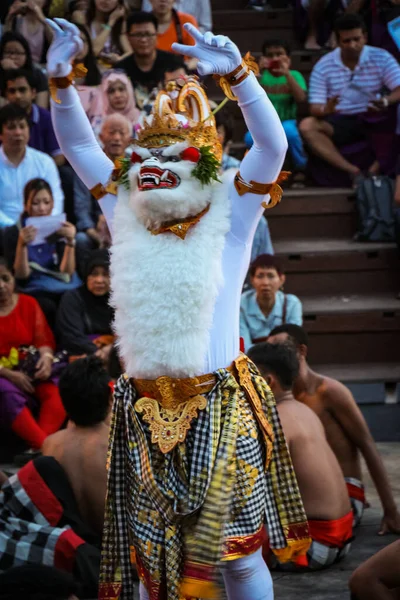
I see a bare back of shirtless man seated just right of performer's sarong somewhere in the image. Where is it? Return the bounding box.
[277,399,351,521]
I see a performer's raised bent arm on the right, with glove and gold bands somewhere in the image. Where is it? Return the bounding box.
[173,24,287,237]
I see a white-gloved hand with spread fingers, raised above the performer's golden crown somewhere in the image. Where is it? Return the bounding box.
[172,23,242,76]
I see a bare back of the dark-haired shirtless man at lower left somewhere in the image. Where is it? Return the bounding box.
[43,423,109,534]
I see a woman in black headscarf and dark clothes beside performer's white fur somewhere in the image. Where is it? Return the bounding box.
[56,250,114,362]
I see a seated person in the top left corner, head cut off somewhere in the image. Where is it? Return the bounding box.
[5,0,53,64]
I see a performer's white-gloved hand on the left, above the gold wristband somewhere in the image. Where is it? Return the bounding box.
[46,19,83,77]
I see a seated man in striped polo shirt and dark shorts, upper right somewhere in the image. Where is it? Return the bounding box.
[300,14,400,179]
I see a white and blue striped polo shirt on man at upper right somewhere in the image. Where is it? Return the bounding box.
[308,46,400,115]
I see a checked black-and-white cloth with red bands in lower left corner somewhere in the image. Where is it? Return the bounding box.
[0,456,100,600]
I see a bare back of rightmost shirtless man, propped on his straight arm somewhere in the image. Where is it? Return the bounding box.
[296,374,362,480]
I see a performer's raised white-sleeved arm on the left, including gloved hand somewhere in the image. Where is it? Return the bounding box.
[47,19,116,229]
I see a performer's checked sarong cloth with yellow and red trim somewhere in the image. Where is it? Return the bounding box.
[100,355,310,600]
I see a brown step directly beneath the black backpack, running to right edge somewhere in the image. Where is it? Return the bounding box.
[274,238,400,298]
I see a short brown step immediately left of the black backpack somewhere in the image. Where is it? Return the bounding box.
[265,188,357,241]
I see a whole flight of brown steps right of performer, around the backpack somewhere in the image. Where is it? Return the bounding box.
[266,188,400,404]
